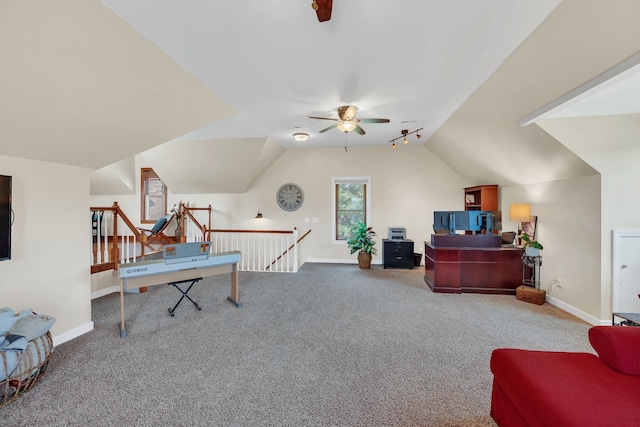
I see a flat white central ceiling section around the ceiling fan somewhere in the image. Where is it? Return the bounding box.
[99,0,559,149]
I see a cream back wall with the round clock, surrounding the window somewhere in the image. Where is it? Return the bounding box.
[91,145,468,291]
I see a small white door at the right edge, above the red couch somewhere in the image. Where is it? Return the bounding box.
[612,230,640,313]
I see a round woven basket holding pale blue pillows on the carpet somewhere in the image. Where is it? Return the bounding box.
[0,332,53,407]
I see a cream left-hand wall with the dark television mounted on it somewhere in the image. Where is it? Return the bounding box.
[0,156,93,344]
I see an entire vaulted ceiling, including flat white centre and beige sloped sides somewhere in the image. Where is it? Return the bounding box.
[0,0,635,194]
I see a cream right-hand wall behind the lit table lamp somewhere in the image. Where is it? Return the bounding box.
[500,175,610,324]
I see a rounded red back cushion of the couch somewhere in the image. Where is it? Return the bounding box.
[589,326,640,375]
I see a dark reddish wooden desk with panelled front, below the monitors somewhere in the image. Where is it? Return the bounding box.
[424,242,524,295]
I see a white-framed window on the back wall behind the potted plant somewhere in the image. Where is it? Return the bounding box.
[332,178,370,242]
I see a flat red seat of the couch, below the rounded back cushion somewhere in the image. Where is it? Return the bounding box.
[490,349,640,427]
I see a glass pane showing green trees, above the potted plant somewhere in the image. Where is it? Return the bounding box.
[335,182,367,240]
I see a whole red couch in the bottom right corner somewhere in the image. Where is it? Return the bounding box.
[490,326,640,427]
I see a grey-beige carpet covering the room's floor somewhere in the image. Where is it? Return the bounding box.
[0,264,592,426]
